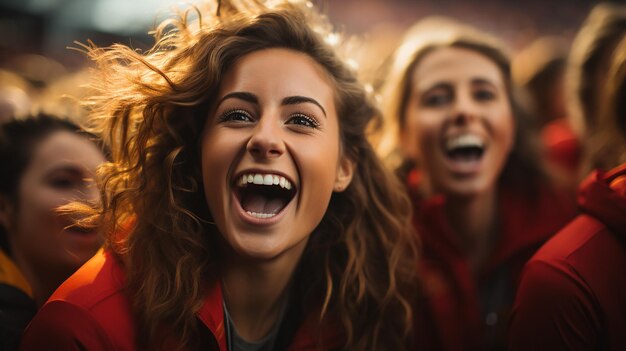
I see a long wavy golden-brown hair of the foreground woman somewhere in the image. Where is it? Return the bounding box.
[80,1,417,350]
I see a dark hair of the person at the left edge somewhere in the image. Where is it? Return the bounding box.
[0,114,106,254]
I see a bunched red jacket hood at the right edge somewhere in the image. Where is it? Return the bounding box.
[578,163,626,238]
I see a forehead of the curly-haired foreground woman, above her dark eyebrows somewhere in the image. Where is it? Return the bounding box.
[220,48,334,107]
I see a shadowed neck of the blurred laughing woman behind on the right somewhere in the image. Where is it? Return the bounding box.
[445,189,498,271]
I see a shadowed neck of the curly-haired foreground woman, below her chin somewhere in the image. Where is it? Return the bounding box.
[222,241,306,341]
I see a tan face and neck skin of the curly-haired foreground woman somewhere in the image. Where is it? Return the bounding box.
[201,49,353,341]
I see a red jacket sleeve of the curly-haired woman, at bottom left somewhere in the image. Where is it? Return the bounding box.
[20,300,115,351]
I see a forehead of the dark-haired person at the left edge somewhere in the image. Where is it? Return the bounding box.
[30,131,105,174]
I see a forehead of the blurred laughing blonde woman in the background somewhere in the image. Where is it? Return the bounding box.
[412,47,504,88]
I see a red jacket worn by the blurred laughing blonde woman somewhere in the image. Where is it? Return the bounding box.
[409,172,575,351]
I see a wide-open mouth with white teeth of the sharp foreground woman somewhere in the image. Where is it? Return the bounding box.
[234,173,297,219]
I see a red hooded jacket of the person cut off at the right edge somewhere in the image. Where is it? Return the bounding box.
[509,164,626,350]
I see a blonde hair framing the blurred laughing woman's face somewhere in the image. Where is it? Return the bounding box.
[374,16,547,192]
